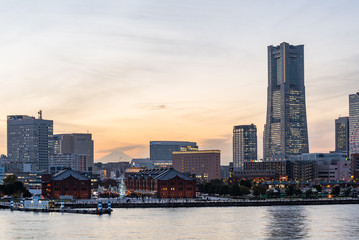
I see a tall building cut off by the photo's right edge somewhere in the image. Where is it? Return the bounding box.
[349,92,359,154]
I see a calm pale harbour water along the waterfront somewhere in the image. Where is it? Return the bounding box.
[0,205,359,240]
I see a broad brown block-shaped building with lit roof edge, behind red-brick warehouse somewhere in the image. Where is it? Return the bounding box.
[172,150,221,181]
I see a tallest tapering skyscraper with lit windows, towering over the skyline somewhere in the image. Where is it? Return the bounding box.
[263,42,309,160]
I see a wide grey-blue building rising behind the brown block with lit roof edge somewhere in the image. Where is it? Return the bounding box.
[150,141,198,160]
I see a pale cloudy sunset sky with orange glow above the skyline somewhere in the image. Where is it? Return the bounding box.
[0,0,359,164]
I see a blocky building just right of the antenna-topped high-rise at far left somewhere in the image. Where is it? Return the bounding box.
[50,133,94,173]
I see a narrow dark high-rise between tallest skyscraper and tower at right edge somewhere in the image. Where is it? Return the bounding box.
[335,117,349,154]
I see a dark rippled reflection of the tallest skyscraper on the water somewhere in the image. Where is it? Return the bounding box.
[265,206,309,239]
